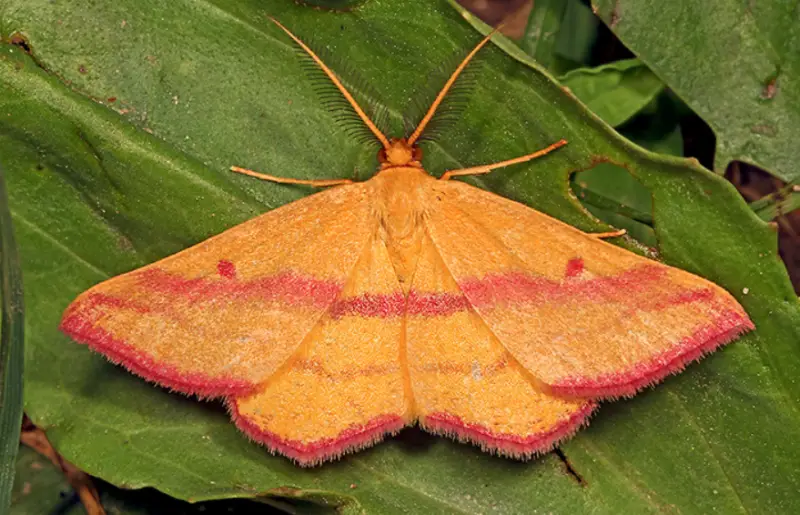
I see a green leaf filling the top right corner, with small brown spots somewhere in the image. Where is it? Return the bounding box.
[592,0,800,181]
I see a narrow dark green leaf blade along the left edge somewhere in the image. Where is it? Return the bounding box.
[0,161,25,513]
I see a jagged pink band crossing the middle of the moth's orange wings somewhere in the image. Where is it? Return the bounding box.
[115,266,714,318]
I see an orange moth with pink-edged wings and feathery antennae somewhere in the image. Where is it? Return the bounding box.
[61,20,754,466]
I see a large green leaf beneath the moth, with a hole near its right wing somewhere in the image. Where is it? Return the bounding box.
[0,0,800,513]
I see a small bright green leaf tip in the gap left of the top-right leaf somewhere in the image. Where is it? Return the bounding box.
[558,59,664,127]
